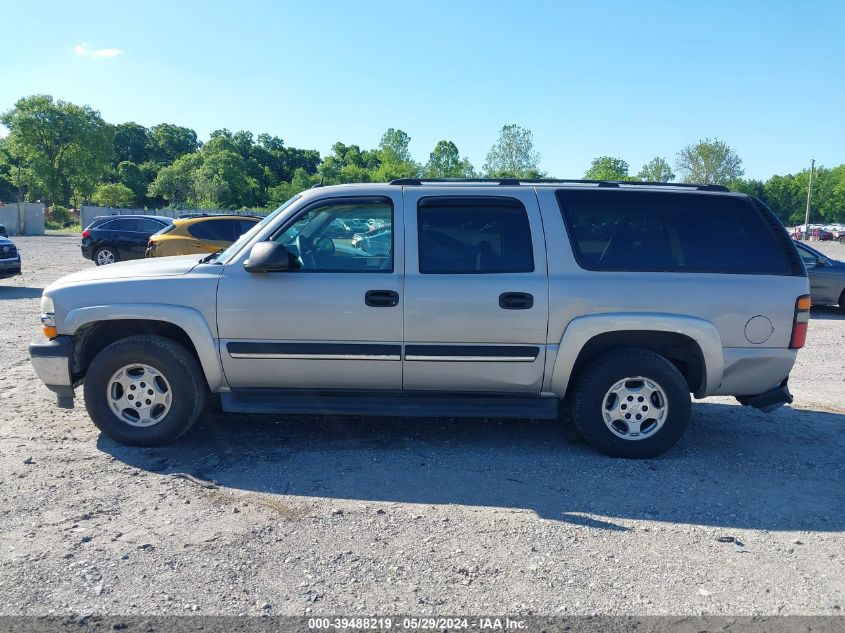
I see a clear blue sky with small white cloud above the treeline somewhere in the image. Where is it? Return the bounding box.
[0,0,845,179]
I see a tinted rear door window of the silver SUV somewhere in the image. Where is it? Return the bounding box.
[417,197,534,274]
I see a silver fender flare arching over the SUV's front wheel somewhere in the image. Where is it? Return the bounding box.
[61,303,226,391]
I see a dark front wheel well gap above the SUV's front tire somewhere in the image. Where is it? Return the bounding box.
[73,319,202,378]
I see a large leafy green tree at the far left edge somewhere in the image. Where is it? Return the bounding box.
[0,95,112,204]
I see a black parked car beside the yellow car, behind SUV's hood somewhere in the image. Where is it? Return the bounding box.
[82,215,173,266]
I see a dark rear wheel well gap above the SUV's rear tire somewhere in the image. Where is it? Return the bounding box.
[572,330,706,393]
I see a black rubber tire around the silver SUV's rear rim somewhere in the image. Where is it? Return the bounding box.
[573,348,691,459]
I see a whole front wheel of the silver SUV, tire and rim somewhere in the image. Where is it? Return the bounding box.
[84,336,207,446]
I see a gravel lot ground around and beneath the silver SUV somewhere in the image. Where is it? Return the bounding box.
[0,237,845,615]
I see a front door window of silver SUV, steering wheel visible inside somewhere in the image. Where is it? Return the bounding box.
[275,199,393,272]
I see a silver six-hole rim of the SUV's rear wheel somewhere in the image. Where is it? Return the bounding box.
[602,376,669,441]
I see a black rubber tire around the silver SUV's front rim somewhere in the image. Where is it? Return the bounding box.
[84,335,208,446]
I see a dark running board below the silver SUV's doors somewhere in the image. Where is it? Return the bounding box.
[220,389,558,420]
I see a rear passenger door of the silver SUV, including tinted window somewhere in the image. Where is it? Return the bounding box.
[403,186,548,394]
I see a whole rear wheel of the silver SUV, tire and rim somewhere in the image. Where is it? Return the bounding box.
[573,349,691,459]
